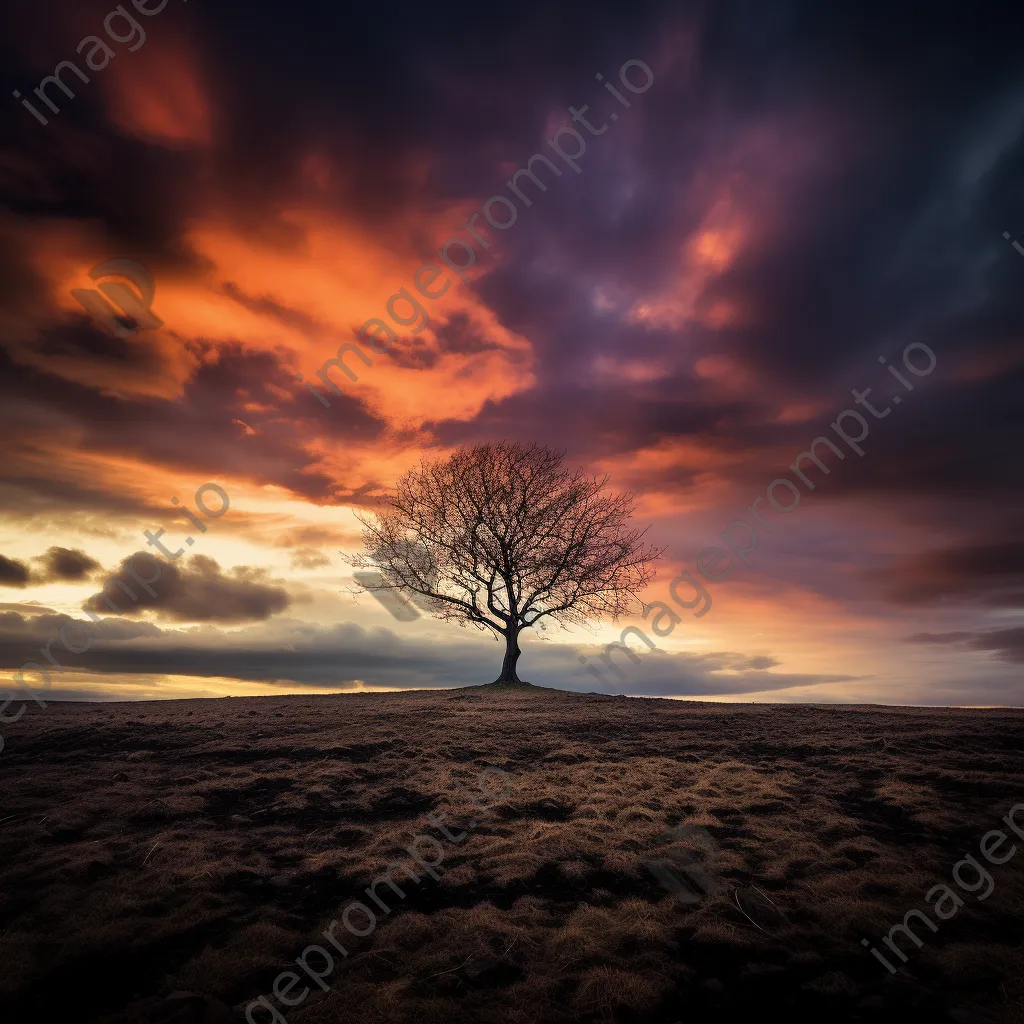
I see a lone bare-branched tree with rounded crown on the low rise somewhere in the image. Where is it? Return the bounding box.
[354,441,662,683]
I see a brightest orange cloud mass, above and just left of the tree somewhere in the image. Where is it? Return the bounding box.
[182,205,534,429]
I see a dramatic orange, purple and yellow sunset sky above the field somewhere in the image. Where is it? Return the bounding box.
[0,0,1024,720]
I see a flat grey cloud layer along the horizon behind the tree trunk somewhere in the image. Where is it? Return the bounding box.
[0,611,851,699]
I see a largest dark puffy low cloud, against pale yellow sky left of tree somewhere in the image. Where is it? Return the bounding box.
[82,552,291,623]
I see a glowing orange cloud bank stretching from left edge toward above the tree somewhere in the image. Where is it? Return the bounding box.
[12,175,534,429]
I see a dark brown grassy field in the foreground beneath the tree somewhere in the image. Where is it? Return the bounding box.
[0,687,1024,1024]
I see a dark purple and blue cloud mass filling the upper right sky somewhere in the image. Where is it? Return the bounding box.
[409,4,1024,536]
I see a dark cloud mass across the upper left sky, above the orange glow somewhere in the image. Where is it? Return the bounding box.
[0,0,659,288]
